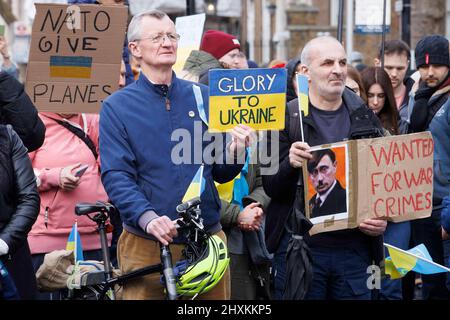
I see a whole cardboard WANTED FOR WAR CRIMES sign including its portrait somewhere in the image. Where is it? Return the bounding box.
[303,132,434,234]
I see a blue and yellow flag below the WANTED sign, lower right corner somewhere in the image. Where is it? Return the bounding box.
[384,243,450,279]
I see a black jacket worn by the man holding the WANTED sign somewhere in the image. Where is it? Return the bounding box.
[263,88,382,252]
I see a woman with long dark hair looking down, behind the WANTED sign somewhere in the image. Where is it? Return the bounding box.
[361,67,407,135]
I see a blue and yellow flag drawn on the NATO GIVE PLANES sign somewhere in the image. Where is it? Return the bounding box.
[50,56,92,79]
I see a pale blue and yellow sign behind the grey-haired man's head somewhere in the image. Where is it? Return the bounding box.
[173,13,206,73]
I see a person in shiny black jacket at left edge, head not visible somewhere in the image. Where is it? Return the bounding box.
[0,125,40,300]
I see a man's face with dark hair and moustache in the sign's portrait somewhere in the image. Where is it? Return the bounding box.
[308,150,337,194]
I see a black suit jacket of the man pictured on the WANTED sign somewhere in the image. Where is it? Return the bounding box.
[309,180,347,218]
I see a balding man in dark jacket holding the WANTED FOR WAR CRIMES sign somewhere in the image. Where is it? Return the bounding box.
[263,37,386,299]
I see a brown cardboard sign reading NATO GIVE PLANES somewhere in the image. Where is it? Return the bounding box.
[25,4,127,113]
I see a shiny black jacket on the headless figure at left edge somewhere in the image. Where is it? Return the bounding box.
[0,125,40,254]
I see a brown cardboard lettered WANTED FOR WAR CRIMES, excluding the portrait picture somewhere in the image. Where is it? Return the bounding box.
[303,132,434,234]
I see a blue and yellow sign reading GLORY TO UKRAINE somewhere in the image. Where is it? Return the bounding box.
[209,69,287,132]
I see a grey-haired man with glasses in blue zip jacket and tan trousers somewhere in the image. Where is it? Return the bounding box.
[100,10,251,299]
